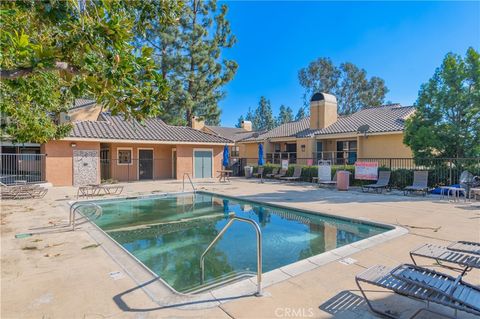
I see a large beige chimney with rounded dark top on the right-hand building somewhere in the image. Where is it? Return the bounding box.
[310,93,338,129]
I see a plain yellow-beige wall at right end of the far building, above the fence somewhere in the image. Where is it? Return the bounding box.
[358,133,413,158]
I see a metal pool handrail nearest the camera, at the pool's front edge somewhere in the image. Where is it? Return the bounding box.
[200,213,262,297]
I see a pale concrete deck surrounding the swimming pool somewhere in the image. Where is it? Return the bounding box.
[1,179,480,318]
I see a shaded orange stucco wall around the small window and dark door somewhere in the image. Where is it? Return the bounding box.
[110,143,175,181]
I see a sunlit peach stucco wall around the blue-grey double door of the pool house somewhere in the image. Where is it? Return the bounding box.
[177,145,223,179]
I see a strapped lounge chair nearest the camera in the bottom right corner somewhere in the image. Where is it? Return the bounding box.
[355,264,480,318]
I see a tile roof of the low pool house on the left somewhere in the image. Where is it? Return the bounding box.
[69,112,232,144]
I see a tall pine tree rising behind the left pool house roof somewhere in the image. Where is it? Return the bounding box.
[142,0,238,125]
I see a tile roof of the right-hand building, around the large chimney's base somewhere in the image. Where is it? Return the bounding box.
[245,104,415,141]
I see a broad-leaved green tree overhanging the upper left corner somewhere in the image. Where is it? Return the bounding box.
[0,0,181,143]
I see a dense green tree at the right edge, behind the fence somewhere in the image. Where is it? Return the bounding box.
[404,48,480,158]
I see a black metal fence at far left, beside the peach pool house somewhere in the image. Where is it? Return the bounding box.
[0,153,45,185]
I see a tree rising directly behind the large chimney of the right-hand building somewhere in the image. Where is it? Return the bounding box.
[298,58,388,114]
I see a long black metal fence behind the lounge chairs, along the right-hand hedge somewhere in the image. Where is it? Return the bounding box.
[232,157,480,188]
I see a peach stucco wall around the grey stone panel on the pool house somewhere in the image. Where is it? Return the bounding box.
[41,141,100,186]
